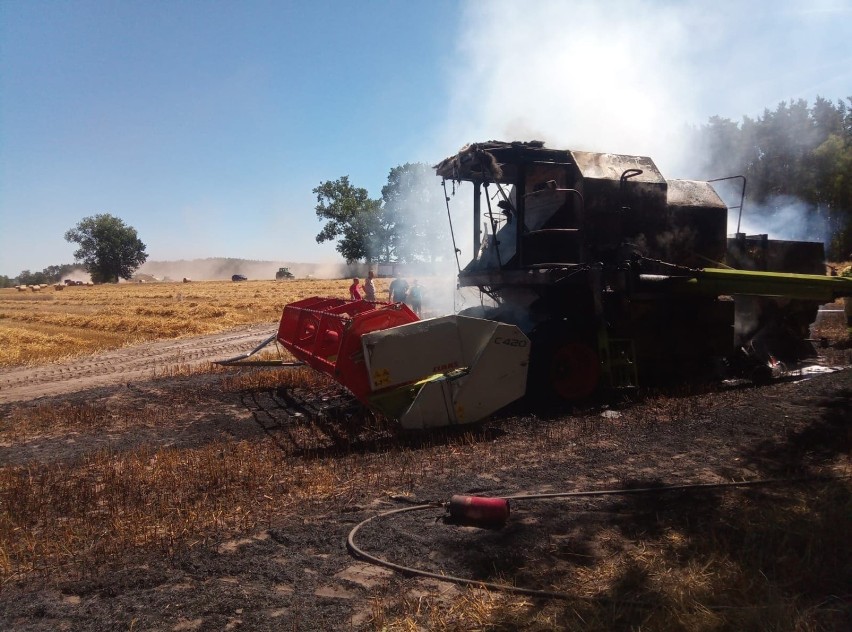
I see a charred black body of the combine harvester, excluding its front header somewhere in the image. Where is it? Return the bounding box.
[435,141,850,398]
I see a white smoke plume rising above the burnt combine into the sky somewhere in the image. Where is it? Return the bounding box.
[416,0,852,292]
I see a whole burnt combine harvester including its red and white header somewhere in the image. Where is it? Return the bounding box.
[243,141,852,428]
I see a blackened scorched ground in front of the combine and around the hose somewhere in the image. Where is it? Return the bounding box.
[0,324,852,630]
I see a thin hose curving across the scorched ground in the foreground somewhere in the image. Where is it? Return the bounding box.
[346,475,852,605]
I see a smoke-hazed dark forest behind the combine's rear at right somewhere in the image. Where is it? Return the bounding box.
[696,97,852,261]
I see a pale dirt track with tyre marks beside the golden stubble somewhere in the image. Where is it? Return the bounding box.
[0,323,276,403]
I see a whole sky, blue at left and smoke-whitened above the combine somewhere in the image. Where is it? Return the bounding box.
[0,0,852,276]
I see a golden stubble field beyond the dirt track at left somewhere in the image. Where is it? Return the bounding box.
[0,279,387,367]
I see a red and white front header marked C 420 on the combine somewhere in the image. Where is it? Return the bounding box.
[276,297,529,429]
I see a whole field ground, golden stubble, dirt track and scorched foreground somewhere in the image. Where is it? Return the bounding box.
[0,280,852,631]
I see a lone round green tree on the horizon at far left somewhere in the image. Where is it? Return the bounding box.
[65,213,148,283]
